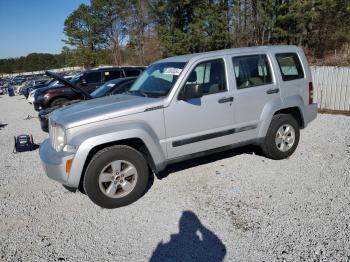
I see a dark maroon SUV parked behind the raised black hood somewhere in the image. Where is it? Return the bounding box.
[33,67,145,111]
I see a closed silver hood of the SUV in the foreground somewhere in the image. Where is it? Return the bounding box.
[50,94,163,129]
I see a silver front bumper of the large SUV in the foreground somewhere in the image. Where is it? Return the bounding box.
[39,139,77,187]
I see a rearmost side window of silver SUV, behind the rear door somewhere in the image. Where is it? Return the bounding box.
[276,53,304,81]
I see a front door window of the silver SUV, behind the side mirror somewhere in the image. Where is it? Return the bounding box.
[186,59,227,95]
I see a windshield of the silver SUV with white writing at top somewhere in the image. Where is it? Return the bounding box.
[128,62,186,97]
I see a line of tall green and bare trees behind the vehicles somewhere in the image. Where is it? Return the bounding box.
[0,0,350,71]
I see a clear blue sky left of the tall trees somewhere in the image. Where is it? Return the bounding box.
[0,0,90,59]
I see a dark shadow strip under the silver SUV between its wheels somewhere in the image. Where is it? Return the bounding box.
[156,145,263,180]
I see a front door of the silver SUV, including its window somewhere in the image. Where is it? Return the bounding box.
[164,58,234,159]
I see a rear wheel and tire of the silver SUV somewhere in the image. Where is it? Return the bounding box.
[261,114,300,160]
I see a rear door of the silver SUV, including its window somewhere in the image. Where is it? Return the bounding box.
[231,53,281,140]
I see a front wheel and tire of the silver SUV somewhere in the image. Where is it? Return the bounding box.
[83,145,149,209]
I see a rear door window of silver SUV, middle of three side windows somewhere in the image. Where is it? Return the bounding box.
[232,55,272,89]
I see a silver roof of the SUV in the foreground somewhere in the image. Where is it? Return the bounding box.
[156,45,300,63]
